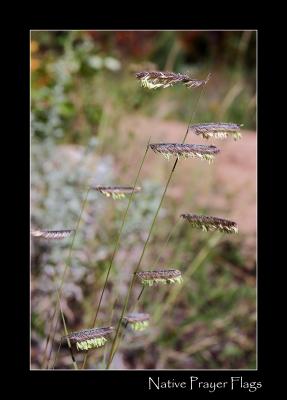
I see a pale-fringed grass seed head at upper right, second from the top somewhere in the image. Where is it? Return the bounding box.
[189,122,243,140]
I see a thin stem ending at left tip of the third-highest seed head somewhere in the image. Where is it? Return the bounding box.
[82,137,151,369]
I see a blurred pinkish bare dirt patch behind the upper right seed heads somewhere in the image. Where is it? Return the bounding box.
[120,116,257,260]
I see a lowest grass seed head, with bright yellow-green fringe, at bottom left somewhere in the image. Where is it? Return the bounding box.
[64,326,114,351]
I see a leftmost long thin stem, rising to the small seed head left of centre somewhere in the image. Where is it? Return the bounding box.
[42,187,90,365]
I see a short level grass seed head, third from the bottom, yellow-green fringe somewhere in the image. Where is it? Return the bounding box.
[137,269,182,286]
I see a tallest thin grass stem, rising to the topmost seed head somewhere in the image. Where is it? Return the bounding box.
[106,80,208,369]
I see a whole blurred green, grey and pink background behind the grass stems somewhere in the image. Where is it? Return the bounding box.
[31,31,256,369]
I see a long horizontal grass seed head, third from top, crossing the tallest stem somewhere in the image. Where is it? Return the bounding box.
[150,143,220,163]
